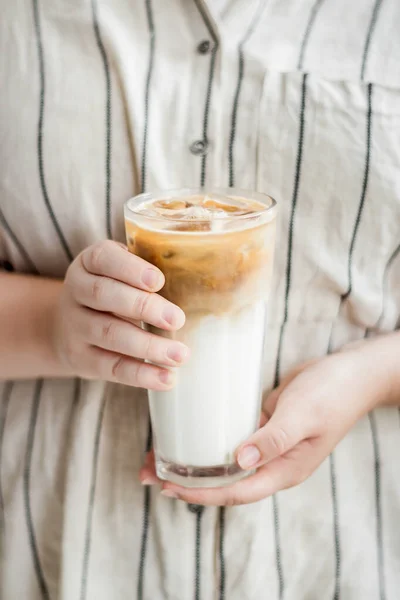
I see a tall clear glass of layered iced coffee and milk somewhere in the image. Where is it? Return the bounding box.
[125,188,276,487]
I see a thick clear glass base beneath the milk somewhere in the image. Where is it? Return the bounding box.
[156,456,254,488]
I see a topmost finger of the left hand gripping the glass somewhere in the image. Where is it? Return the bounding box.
[81,240,165,292]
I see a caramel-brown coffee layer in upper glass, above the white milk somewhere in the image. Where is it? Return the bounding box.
[126,220,275,314]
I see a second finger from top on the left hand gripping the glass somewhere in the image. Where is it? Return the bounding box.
[68,269,185,330]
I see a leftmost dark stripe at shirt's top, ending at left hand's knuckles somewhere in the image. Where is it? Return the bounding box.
[32,0,73,261]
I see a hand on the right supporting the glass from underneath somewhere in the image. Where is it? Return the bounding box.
[140,342,393,506]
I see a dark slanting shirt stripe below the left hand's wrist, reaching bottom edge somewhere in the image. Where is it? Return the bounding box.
[80,398,106,600]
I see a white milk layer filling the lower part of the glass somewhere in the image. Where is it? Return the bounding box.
[149,301,266,467]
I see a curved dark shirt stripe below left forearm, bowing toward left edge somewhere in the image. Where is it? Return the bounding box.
[24,379,50,600]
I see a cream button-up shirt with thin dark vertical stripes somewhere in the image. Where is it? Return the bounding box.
[0,0,400,600]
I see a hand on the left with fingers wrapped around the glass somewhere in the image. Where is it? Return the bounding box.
[53,241,189,390]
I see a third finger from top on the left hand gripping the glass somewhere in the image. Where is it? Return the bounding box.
[81,310,189,367]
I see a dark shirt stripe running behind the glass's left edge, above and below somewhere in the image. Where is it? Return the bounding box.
[137,0,156,600]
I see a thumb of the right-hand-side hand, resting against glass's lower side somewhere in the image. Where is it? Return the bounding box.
[237,410,304,469]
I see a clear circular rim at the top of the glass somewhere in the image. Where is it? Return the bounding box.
[124,187,277,223]
